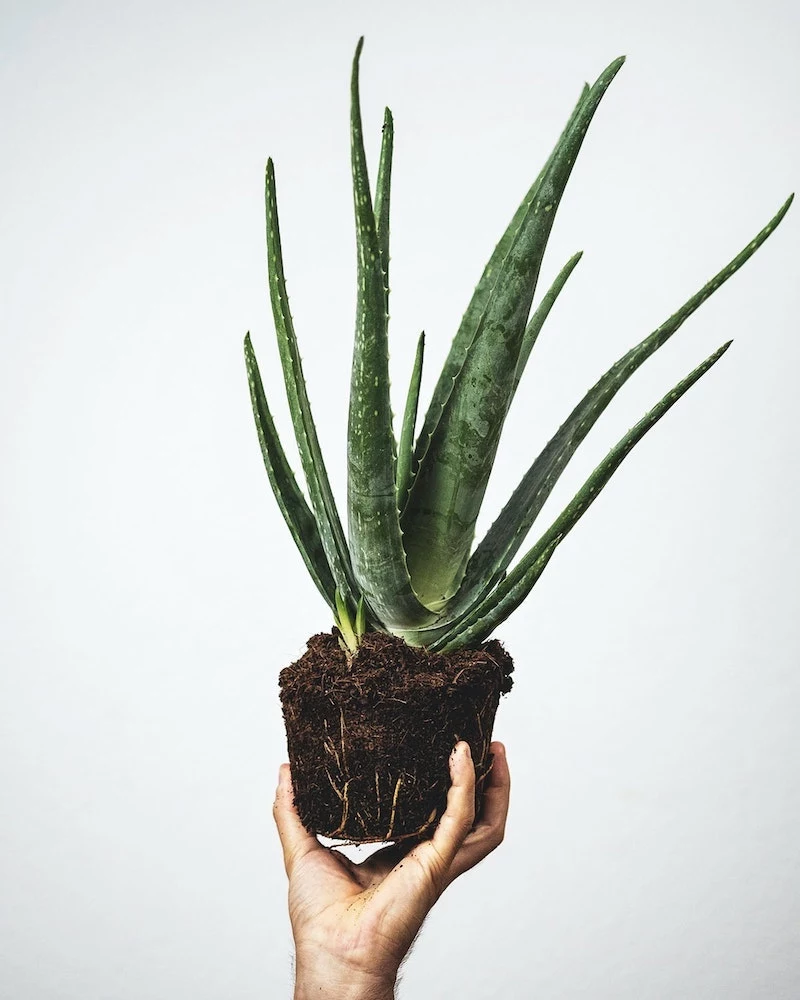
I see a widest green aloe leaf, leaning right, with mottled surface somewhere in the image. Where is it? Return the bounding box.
[403,59,623,610]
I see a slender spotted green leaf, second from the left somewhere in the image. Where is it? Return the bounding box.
[266,159,360,617]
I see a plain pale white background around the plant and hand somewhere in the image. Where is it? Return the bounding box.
[0,0,800,1000]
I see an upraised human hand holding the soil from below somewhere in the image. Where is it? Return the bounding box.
[273,741,510,1000]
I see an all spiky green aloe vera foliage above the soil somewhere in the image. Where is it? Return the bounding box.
[245,39,792,652]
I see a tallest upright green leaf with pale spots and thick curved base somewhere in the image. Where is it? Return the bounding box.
[347,39,432,630]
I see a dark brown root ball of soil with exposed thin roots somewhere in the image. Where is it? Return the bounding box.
[280,629,514,843]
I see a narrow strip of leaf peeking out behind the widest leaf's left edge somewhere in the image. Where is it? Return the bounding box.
[410,83,590,492]
